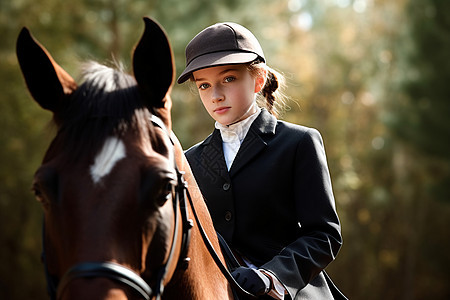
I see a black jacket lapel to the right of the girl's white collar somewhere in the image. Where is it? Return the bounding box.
[229,109,277,177]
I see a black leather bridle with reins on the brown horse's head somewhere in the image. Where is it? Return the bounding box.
[42,115,256,300]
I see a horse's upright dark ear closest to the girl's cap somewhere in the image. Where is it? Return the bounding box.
[133,17,175,108]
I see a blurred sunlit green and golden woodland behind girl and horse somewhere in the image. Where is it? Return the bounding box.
[0,0,450,300]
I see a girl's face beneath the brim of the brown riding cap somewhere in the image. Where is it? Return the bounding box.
[193,65,264,125]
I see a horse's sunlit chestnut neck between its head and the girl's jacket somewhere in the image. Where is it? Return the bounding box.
[168,140,233,299]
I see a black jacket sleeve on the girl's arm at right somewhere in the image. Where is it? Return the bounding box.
[261,129,342,299]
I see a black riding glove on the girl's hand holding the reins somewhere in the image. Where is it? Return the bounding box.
[231,267,270,296]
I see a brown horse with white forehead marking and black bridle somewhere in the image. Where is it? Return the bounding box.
[17,18,239,299]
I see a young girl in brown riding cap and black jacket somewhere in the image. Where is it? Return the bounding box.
[178,23,345,300]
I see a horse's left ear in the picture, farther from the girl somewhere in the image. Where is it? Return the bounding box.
[16,27,77,112]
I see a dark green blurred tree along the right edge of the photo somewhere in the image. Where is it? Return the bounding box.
[383,0,450,299]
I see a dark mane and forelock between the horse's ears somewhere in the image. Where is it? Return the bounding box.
[44,62,154,161]
